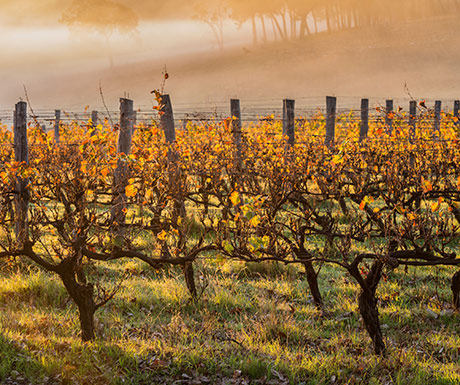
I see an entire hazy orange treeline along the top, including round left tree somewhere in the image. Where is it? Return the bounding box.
[52,0,460,47]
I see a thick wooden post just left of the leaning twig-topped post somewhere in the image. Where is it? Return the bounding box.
[111,98,134,236]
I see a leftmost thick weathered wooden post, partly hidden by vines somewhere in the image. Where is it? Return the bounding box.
[14,102,29,247]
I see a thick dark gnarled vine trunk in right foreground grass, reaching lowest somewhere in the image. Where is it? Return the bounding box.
[358,261,385,355]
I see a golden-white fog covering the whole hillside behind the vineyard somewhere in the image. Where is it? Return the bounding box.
[0,0,460,110]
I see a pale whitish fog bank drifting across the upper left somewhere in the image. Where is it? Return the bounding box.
[0,20,255,109]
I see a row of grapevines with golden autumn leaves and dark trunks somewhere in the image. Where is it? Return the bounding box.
[0,106,460,353]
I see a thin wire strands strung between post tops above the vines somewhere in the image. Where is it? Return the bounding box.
[0,96,456,130]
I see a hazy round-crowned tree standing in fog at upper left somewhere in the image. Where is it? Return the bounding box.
[60,0,139,68]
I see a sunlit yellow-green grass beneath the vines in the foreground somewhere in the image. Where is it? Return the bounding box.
[0,260,460,385]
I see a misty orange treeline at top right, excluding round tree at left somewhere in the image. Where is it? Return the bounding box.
[121,0,460,45]
